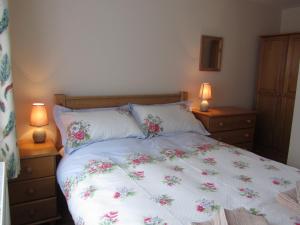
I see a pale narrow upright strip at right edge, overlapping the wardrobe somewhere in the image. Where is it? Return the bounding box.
[288,66,300,168]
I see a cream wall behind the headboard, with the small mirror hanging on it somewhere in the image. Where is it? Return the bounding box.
[10,0,280,141]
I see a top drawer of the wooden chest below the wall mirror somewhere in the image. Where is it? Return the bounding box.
[208,115,256,132]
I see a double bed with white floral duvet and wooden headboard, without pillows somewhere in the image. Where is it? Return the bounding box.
[56,92,300,225]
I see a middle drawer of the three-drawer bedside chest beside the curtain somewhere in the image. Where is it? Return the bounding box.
[9,177,56,204]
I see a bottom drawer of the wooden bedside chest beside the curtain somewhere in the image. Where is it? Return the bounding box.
[11,198,57,225]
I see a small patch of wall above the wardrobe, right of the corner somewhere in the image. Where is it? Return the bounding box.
[280,7,300,33]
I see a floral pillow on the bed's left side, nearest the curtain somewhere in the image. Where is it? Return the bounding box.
[54,105,145,154]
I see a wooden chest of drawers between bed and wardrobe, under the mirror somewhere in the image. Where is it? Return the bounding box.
[193,107,256,150]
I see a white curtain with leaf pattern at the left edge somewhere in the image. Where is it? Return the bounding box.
[0,0,20,179]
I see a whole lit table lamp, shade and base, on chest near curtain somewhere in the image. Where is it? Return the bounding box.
[30,103,48,143]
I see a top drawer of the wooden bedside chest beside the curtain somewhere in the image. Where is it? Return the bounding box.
[17,157,56,181]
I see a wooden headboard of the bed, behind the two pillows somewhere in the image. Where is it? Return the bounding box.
[55,91,188,149]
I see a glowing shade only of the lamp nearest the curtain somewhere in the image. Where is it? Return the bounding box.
[30,103,48,127]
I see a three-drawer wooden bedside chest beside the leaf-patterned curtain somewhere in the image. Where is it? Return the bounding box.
[8,140,60,225]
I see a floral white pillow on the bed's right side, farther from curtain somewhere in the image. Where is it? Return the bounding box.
[130,102,209,137]
